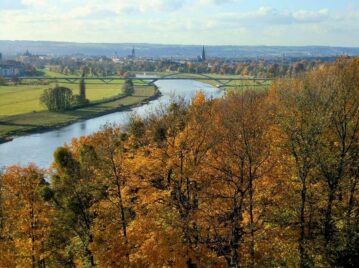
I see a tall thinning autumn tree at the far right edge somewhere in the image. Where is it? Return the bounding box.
[313,58,359,264]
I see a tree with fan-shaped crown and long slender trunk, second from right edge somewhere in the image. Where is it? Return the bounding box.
[272,76,329,267]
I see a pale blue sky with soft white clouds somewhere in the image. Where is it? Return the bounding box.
[0,0,359,47]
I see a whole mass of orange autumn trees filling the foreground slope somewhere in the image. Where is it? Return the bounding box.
[0,59,359,267]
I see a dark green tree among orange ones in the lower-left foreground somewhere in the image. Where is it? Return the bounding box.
[47,147,98,267]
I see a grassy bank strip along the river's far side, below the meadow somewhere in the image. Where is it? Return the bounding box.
[0,86,161,143]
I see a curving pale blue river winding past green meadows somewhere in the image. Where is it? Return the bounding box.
[0,80,223,168]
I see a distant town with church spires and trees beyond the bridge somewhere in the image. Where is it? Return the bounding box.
[0,43,356,79]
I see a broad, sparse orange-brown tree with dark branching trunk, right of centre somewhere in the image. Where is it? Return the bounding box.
[195,91,271,267]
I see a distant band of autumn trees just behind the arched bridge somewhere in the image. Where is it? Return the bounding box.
[49,58,334,77]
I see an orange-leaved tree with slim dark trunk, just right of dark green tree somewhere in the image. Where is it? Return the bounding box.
[86,125,136,267]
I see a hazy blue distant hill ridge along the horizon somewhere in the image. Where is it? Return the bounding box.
[0,40,359,58]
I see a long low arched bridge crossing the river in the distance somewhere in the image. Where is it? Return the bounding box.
[7,73,273,88]
